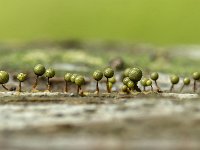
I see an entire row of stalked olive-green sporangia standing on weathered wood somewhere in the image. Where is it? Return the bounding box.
[0,64,200,95]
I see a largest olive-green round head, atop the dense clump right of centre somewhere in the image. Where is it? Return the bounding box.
[129,68,142,82]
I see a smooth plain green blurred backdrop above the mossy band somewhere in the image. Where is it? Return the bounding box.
[0,0,200,45]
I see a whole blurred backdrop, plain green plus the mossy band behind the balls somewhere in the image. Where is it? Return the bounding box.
[0,0,200,74]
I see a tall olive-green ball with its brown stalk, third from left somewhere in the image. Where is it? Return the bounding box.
[32,64,46,91]
